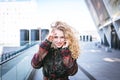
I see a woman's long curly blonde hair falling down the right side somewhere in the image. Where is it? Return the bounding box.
[51,21,80,59]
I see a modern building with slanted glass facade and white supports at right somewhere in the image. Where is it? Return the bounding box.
[85,0,120,50]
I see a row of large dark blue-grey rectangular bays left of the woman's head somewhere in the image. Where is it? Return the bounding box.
[19,29,49,46]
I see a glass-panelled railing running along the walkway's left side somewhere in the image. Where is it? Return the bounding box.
[0,43,38,80]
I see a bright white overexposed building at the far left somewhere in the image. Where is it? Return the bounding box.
[0,0,40,46]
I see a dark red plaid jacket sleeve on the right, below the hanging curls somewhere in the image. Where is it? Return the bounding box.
[62,48,78,76]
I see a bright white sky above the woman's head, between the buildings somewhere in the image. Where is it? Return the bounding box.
[37,0,96,31]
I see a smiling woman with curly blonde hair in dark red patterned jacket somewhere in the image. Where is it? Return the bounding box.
[31,21,79,80]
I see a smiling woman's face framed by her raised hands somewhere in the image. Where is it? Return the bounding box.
[53,29,65,48]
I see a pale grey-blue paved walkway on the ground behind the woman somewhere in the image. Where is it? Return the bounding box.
[33,42,120,80]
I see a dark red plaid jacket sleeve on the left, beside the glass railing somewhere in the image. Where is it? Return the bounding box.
[31,39,51,69]
